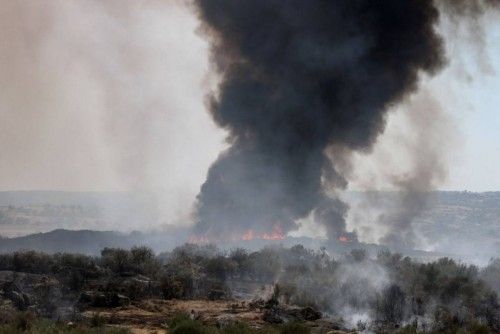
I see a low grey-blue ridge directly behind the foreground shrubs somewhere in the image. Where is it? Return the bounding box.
[0,229,450,261]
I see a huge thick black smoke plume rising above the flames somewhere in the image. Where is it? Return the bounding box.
[194,0,492,238]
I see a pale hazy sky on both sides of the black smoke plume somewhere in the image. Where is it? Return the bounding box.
[0,0,500,206]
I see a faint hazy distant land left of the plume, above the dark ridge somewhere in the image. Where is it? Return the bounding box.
[0,191,159,237]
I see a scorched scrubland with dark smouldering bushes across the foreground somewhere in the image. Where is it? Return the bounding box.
[0,244,500,333]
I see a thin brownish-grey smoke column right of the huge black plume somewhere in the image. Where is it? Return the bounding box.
[378,90,456,248]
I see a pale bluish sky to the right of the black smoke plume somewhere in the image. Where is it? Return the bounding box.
[352,13,500,191]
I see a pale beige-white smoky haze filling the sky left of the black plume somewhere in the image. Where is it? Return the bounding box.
[0,0,223,228]
